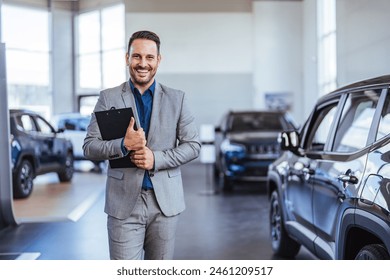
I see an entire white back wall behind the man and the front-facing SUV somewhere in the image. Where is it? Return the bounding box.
[125,0,304,124]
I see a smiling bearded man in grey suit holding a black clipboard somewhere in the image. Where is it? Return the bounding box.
[83,31,200,260]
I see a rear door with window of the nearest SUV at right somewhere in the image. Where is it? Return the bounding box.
[312,89,382,259]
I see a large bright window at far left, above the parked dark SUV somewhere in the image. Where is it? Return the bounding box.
[1,4,52,112]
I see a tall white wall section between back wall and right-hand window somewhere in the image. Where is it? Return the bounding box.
[253,1,303,121]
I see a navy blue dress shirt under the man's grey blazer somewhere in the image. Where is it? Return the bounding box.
[129,80,156,189]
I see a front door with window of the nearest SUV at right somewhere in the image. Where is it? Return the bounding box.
[286,97,339,252]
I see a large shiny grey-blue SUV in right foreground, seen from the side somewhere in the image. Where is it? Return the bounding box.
[268,75,390,259]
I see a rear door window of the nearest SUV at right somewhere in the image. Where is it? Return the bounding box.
[332,90,381,153]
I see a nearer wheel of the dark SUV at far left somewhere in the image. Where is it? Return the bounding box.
[13,159,34,198]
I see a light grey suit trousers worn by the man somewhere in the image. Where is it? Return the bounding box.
[107,190,179,260]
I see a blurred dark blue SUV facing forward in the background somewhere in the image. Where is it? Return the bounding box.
[214,111,295,190]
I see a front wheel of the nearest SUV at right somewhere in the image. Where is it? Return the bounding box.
[270,191,301,258]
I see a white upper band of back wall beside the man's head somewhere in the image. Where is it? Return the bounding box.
[126,13,253,74]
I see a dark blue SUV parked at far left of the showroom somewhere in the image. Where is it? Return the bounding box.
[10,110,73,198]
